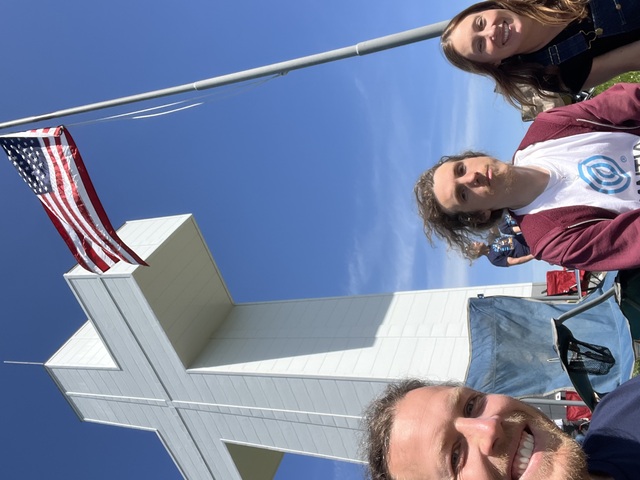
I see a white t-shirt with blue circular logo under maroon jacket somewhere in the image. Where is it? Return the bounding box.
[513,132,640,215]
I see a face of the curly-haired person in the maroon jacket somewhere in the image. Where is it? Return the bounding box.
[433,157,514,218]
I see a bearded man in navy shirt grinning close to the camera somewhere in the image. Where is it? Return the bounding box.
[364,378,640,480]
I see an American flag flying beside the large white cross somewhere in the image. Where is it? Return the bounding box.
[0,126,146,273]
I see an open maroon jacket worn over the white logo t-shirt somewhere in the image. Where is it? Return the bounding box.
[514,83,640,271]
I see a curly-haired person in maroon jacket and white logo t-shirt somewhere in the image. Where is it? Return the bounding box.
[414,84,640,271]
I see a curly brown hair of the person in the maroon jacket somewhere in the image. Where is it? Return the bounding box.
[413,150,504,260]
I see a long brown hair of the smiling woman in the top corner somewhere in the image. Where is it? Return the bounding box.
[440,0,589,108]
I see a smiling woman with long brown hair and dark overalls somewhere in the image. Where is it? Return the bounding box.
[441,0,640,106]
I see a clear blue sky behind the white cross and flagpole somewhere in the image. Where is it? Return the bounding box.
[0,0,549,480]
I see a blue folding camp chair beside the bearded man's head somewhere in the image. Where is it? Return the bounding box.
[465,273,635,408]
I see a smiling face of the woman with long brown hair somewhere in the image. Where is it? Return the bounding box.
[449,9,528,65]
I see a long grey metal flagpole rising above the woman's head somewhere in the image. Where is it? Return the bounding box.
[0,21,449,129]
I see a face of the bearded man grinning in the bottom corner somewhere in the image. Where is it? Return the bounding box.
[388,386,589,480]
